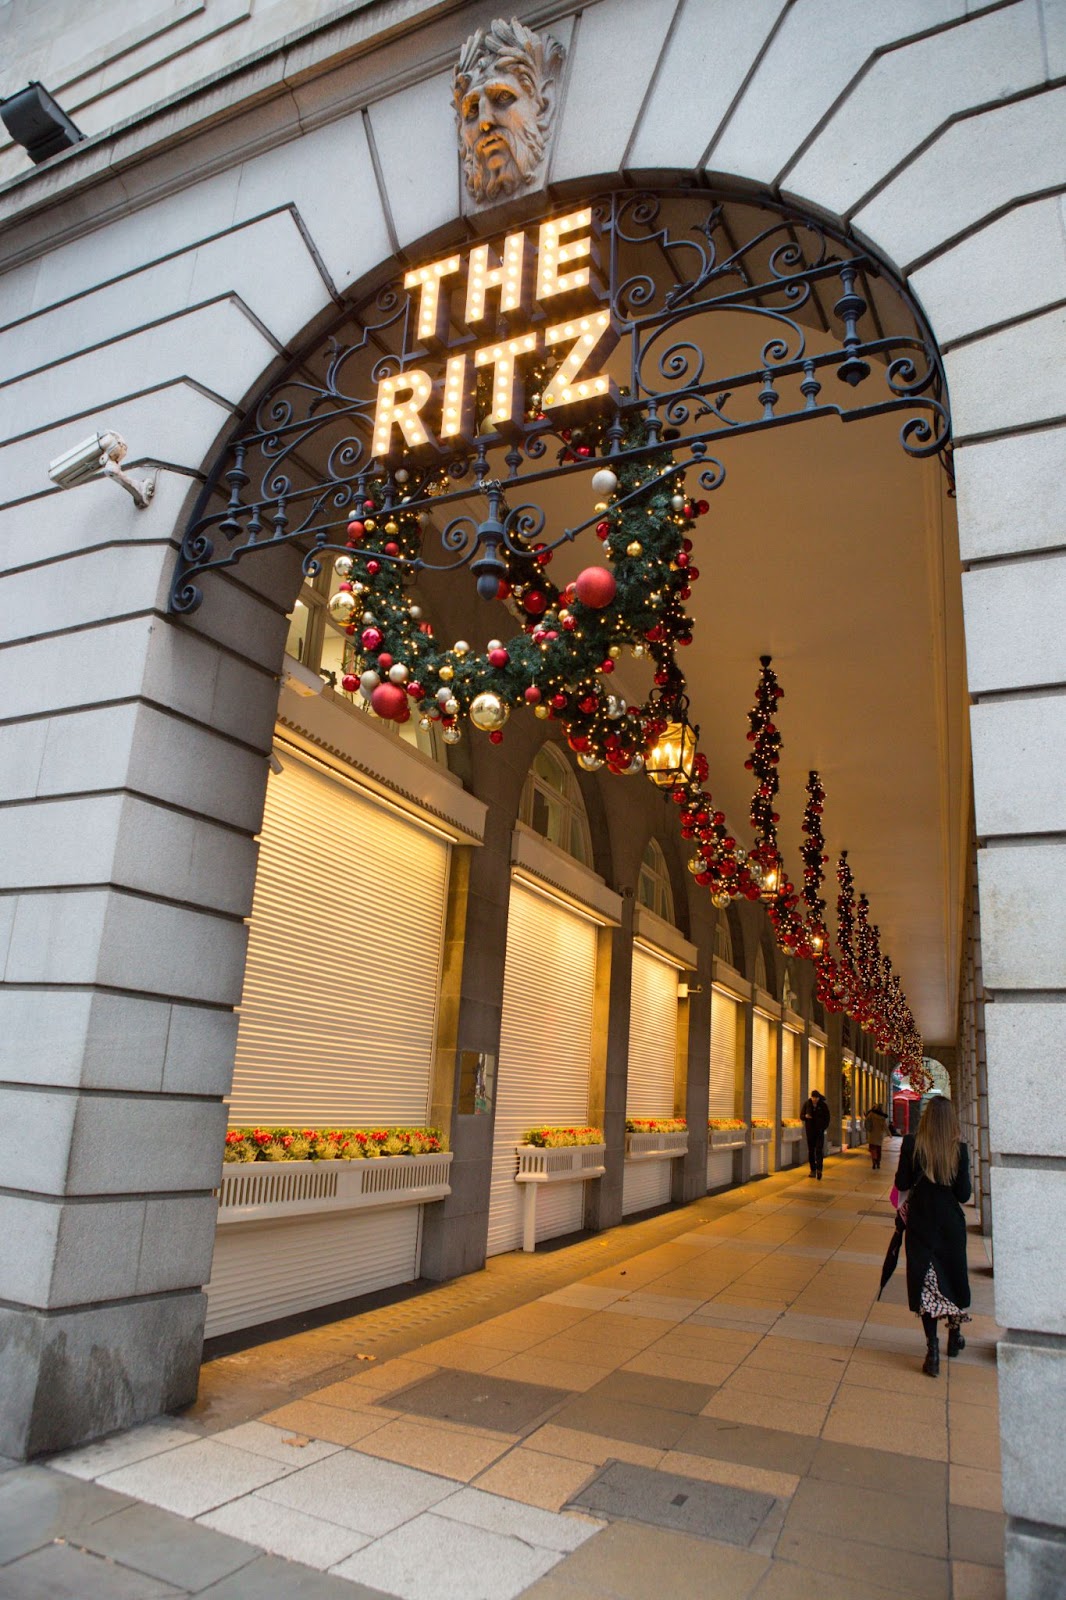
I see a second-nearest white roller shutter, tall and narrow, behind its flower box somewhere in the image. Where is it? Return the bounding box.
[488,883,597,1256]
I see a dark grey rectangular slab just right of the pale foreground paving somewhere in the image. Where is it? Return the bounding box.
[571,1461,775,1547]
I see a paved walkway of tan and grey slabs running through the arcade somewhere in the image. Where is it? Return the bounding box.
[0,1152,1004,1600]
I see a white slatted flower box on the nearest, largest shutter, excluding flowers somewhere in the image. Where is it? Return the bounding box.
[218,1150,451,1227]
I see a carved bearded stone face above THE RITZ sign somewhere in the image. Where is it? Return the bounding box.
[453,19,563,203]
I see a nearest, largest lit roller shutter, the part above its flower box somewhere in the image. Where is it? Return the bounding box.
[230,752,450,1126]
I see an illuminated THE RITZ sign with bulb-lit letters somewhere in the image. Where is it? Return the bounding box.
[373,208,618,461]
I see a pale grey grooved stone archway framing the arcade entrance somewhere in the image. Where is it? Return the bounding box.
[0,37,1066,1587]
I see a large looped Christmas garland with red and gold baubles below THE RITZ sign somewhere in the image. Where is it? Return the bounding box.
[330,425,707,773]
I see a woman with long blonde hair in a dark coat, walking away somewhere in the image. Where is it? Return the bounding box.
[896,1096,972,1378]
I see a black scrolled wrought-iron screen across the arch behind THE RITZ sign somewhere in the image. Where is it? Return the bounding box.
[170,189,951,614]
